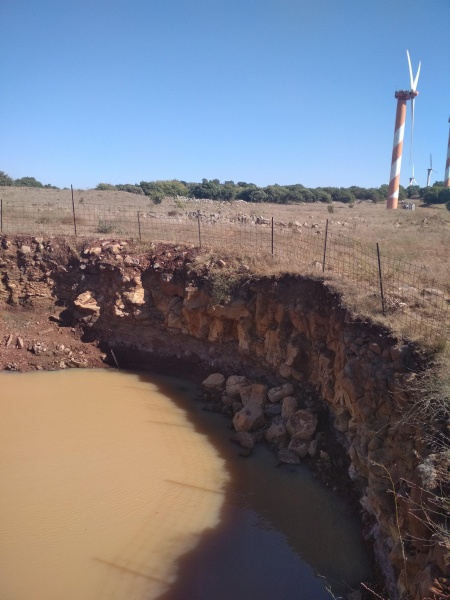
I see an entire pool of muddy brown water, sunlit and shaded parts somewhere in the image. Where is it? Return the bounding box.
[0,370,370,600]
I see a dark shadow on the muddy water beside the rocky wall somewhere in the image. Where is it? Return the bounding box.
[133,373,371,600]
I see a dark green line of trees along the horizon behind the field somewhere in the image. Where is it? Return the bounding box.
[0,171,450,205]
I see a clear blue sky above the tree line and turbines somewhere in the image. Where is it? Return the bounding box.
[0,0,450,188]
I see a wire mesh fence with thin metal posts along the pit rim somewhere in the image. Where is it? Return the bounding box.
[0,197,450,354]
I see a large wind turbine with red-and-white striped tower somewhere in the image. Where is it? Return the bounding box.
[386,50,421,209]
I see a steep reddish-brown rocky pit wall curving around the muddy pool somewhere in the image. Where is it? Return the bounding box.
[0,238,450,600]
